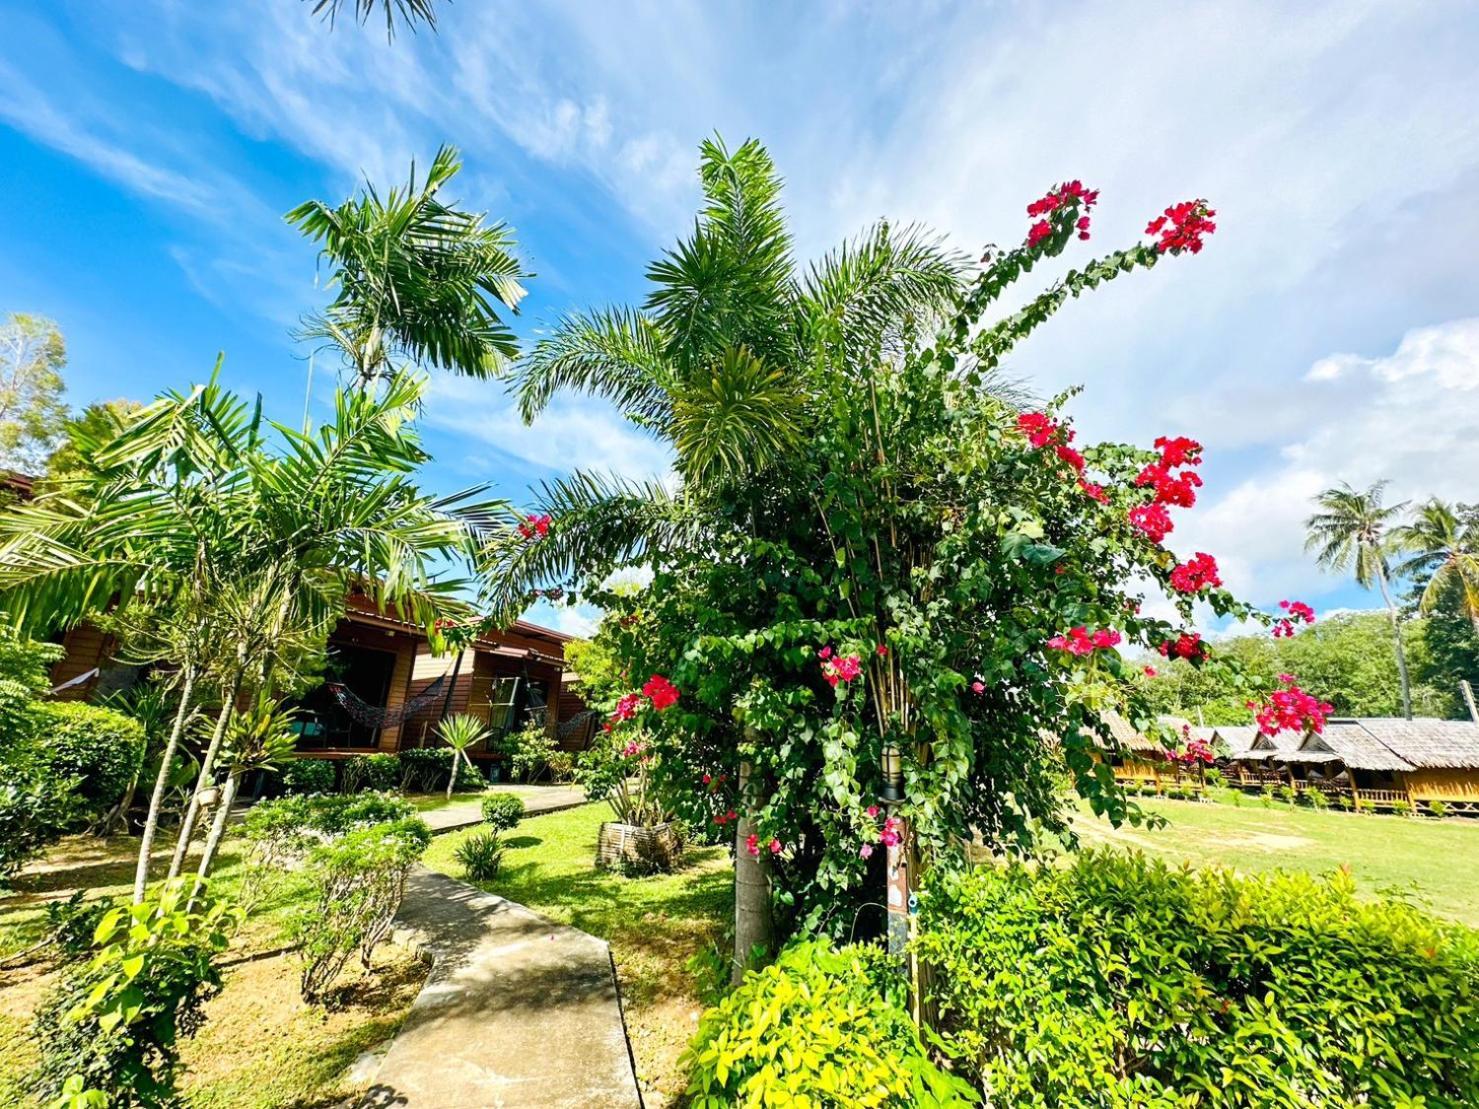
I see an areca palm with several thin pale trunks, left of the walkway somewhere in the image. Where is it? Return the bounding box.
[0,369,503,896]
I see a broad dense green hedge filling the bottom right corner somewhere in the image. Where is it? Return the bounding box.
[917,852,1479,1109]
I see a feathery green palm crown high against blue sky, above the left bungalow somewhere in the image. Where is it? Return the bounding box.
[285,145,528,386]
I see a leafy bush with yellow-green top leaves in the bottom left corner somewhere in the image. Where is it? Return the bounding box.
[30,878,241,1109]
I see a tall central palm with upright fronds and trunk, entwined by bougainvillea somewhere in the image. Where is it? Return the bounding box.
[487,138,966,979]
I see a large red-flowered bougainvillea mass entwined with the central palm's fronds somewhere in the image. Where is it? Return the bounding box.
[482,143,1331,958]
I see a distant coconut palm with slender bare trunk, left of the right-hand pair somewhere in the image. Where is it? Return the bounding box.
[1304,481,1412,720]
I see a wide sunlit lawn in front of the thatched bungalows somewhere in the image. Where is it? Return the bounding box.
[1074,794,1479,927]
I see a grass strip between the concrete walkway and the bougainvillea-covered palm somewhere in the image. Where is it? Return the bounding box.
[426,803,734,1109]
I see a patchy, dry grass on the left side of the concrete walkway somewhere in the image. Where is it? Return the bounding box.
[0,835,426,1109]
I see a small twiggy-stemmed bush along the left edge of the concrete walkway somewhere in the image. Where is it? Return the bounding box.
[288,818,432,1003]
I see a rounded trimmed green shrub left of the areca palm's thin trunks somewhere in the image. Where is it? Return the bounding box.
[31,701,143,818]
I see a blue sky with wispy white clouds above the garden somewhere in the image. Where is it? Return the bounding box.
[0,0,1479,628]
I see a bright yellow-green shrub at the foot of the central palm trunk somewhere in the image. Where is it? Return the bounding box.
[683,940,978,1109]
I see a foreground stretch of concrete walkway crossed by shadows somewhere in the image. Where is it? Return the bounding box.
[355,868,642,1109]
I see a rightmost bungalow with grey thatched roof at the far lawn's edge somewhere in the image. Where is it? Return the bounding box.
[1275,717,1479,813]
